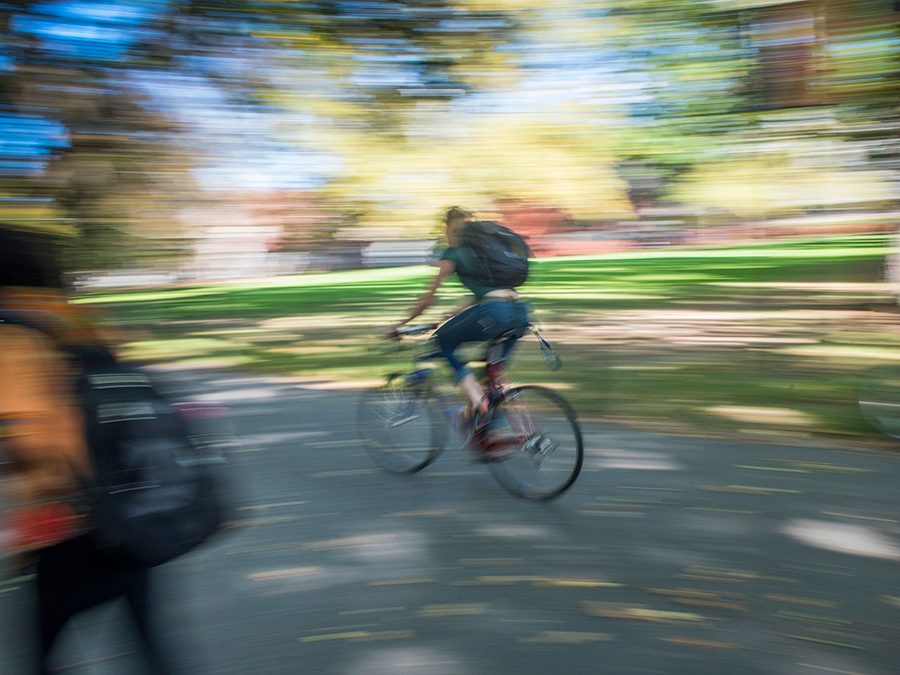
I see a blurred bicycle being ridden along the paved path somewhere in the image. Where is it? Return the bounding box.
[357,324,584,501]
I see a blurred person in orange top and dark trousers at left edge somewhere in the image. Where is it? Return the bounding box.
[0,225,169,675]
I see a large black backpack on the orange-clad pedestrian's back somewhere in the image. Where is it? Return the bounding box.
[73,347,226,567]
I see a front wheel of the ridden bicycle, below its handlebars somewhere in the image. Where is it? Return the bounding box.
[357,374,447,473]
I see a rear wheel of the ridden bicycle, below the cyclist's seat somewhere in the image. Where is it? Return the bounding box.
[488,385,584,500]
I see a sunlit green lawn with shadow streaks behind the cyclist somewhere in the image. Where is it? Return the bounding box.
[79,235,900,447]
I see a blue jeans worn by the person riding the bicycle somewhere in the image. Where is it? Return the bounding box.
[433,298,530,382]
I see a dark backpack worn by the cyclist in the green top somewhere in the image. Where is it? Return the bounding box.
[460,220,531,288]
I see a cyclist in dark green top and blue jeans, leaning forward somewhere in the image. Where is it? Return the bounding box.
[392,207,530,423]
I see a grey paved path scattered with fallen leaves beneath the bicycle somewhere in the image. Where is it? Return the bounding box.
[0,372,900,675]
